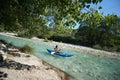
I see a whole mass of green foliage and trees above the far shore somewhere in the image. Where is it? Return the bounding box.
[0,0,120,51]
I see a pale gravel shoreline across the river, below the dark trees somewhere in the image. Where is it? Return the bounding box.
[32,37,120,59]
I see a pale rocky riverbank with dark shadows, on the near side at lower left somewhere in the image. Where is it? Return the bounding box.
[0,42,67,80]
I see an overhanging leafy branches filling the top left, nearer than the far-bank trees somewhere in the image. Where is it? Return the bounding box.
[0,0,102,33]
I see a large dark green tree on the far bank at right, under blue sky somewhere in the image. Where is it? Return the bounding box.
[75,11,120,50]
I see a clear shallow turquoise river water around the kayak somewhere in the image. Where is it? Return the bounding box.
[0,35,120,80]
